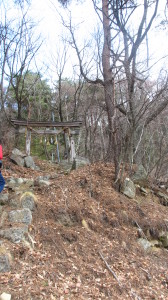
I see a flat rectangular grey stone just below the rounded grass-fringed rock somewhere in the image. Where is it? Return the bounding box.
[8,208,32,224]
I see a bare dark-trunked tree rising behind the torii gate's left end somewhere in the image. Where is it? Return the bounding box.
[7,14,41,119]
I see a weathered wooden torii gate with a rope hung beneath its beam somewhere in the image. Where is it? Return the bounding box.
[11,119,82,161]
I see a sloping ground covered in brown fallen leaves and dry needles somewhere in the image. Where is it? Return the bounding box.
[0,158,168,300]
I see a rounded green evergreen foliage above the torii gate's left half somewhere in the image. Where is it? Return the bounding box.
[8,71,52,121]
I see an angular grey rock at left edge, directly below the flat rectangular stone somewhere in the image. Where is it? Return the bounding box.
[0,225,28,243]
